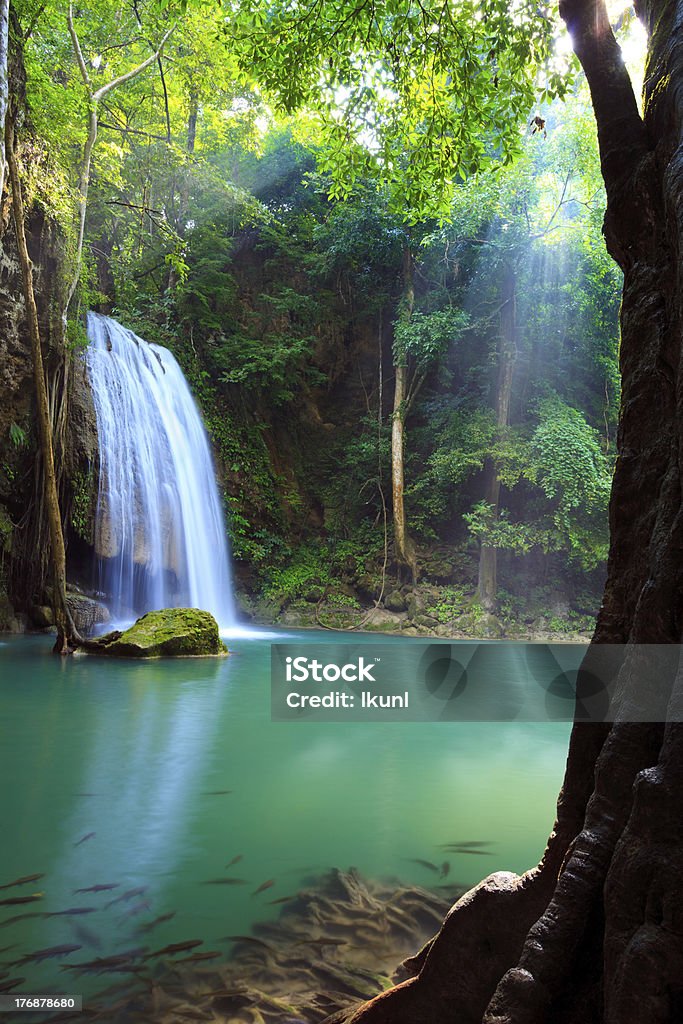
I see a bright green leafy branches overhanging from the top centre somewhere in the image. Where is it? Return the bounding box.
[224,0,566,221]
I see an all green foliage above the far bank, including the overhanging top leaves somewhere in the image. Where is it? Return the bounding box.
[10,0,621,622]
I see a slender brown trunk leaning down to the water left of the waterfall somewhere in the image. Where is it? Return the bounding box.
[5,117,81,654]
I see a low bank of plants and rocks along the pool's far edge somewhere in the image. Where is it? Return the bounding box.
[238,548,601,642]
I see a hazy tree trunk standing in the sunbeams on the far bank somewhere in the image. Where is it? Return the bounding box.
[477,264,517,614]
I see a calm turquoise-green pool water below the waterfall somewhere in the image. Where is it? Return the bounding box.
[0,632,569,991]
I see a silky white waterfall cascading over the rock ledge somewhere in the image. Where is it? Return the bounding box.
[86,313,234,628]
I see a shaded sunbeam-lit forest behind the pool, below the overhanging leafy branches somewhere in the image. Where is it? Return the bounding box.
[0,3,621,636]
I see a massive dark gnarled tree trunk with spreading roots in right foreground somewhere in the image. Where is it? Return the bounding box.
[323,0,683,1024]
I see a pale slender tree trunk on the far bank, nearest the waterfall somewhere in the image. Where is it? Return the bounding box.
[391,246,417,583]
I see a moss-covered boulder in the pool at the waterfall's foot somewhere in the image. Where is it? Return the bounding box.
[87,608,227,657]
